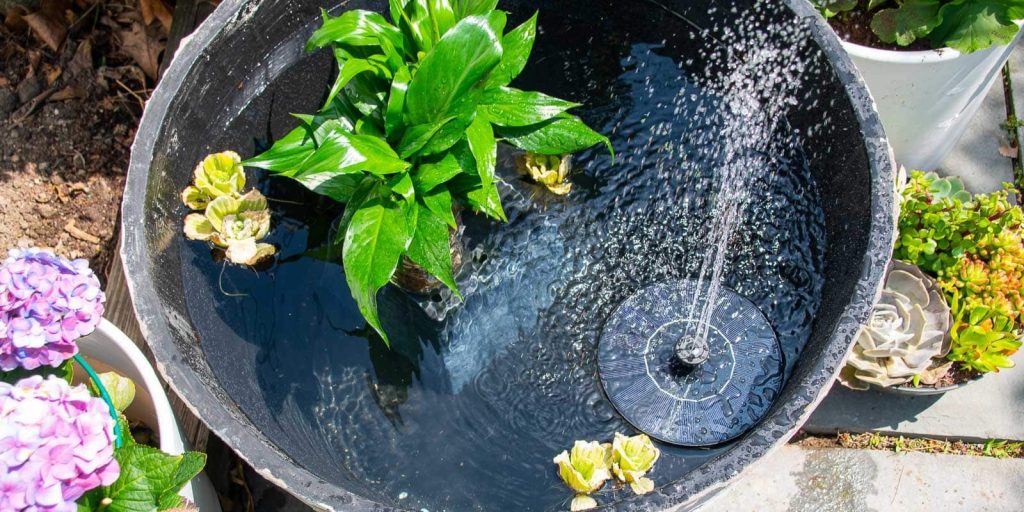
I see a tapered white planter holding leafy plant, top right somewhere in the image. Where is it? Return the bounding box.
[843,32,1021,171]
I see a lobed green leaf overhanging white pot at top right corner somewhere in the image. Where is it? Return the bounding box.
[929,0,1021,53]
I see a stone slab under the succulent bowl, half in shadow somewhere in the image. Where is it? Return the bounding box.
[804,352,1024,441]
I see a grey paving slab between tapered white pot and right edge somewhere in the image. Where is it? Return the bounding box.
[937,50,1024,193]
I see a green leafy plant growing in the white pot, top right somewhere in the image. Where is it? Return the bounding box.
[813,0,1024,53]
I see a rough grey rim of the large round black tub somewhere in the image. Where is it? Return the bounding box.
[121,0,896,511]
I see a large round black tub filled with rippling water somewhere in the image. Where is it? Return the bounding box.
[122,0,895,511]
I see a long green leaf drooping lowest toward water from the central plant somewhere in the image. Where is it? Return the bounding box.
[342,191,415,346]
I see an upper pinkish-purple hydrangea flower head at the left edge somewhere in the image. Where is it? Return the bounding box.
[0,249,105,372]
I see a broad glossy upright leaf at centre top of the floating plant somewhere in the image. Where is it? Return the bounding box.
[406,12,502,125]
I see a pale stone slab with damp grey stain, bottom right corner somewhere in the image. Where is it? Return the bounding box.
[699,445,1024,512]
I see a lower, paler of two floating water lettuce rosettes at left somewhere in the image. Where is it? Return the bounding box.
[185,189,276,265]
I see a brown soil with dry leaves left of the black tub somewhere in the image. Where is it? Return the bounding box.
[0,18,146,280]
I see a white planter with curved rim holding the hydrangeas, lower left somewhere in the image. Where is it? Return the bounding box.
[75,319,220,512]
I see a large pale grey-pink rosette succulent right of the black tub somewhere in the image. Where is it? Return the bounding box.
[840,260,951,389]
